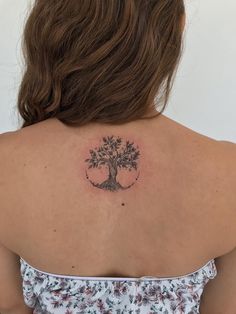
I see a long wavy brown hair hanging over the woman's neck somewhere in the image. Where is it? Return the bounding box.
[17,0,185,128]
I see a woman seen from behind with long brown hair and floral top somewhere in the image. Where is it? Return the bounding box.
[0,0,236,314]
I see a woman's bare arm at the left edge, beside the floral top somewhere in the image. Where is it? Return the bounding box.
[0,132,32,314]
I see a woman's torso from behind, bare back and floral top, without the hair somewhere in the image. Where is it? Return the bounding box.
[0,116,235,314]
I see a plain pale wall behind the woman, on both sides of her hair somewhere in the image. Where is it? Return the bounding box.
[0,0,236,143]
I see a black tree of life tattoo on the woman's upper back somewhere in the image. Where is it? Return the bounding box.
[85,135,140,191]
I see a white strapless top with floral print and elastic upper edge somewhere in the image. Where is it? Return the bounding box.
[20,258,217,314]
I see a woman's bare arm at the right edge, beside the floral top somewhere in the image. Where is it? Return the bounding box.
[200,141,236,314]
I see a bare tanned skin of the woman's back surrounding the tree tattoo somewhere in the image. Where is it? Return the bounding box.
[0,115,235,277]
